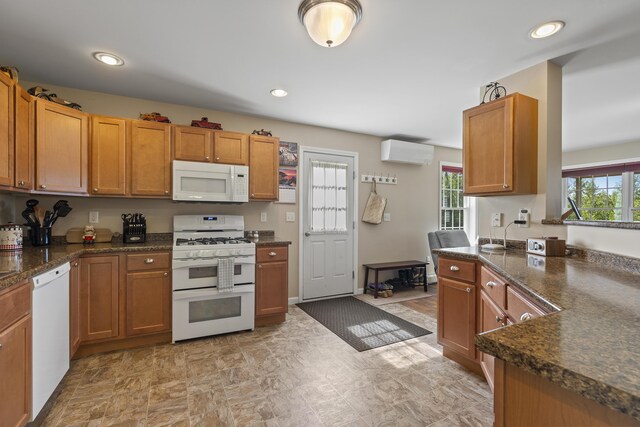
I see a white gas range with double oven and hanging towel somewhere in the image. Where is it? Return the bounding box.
[172,215,256,342]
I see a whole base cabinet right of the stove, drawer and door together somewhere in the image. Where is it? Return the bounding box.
[255,245,289,326]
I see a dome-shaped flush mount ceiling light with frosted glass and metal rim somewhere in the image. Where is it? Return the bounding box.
[298,0,362,47]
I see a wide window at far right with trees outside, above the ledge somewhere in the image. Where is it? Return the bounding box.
[562,162,640,221]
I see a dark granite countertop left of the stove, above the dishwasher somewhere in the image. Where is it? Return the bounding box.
[0,240,173,291]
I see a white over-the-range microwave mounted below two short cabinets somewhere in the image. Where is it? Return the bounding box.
[173,160,249,203]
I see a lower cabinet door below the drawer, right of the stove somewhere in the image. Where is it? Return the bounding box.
[256,261,289,316]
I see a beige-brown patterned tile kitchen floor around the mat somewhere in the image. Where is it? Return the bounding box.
[43,297,493,427]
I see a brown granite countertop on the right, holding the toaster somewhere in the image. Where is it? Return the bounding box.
[437,247,640,420]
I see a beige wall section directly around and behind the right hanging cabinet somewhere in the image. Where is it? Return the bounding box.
[477,62,566,244]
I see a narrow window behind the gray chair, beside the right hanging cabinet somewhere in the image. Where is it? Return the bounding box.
[440,164,466,230]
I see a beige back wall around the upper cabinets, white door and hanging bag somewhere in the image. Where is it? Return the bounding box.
[10,82,462,297]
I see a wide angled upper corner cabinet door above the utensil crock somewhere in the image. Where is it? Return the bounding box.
[36,99,89,193]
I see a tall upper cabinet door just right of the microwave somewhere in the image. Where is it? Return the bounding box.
[249,135,280,200]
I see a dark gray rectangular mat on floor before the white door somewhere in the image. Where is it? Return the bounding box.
[297,296,431,351]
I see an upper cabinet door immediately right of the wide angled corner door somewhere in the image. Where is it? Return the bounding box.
[91,116,127,196]
